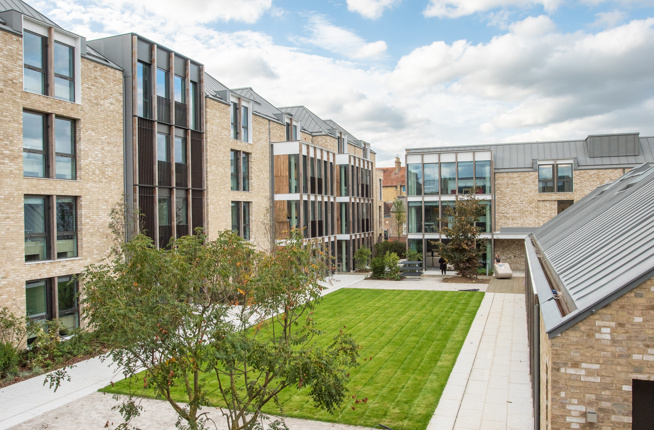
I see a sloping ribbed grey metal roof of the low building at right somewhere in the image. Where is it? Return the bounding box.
[530,164,654,335]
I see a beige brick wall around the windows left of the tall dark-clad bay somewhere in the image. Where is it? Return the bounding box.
[0,31,123,315]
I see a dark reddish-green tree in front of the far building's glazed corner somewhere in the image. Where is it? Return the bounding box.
[438,190,484,278]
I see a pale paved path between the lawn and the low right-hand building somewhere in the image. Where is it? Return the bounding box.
[427,293,534,430]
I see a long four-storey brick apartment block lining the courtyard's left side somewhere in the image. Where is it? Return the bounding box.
[0,0,381,327]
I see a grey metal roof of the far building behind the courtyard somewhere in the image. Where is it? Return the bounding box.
[407,133,654,171]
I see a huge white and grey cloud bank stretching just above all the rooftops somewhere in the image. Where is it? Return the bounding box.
[35,0,654,165]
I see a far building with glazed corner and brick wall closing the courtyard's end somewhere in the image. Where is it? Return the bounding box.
[406,133,654,270]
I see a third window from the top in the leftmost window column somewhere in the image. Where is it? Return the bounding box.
[24,196,78,261]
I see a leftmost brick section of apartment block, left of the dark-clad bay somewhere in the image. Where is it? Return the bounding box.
[0,0,124,328]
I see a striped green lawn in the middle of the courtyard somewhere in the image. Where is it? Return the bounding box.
[103,289,484,430]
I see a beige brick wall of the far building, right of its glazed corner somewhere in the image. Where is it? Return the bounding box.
[494,169,624,231]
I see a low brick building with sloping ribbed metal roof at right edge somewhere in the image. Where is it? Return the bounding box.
[525,164,654,430]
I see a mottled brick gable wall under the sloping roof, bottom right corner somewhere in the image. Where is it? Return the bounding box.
[540,278,654,430]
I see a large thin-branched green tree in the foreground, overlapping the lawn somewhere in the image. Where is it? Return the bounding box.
[81,231,359,430]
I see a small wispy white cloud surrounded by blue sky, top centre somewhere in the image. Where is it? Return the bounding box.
[297,15,388,60]
